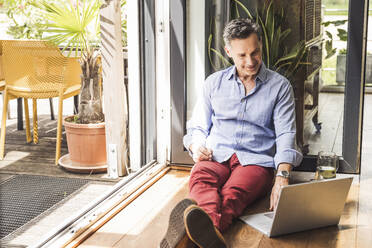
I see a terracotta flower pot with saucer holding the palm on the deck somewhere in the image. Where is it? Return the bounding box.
[60,117,107,173]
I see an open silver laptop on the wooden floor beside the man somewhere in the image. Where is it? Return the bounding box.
[240,177,353,237]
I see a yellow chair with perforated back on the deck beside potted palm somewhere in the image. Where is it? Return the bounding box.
[0,40,81,165]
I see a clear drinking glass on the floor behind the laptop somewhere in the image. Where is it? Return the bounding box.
[315,151,338,180]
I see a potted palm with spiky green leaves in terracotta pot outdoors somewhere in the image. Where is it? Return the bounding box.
[36,0,107,173]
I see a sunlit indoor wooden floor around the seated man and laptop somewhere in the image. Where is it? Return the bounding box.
[79,166,372,248]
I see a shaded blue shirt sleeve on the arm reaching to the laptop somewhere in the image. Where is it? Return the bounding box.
[273,81,302,168]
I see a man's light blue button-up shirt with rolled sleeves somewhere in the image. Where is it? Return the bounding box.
[183,63,302,168]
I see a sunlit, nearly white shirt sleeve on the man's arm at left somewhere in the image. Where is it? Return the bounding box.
[183,77,213,151]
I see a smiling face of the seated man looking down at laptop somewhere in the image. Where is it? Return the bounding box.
[225,34,262,78]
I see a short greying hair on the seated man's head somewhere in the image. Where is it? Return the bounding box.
[223,18,261,46]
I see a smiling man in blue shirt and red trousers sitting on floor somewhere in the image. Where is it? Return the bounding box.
[160,19,302,248]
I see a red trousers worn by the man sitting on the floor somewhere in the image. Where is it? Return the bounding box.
[189,154,274,232]
